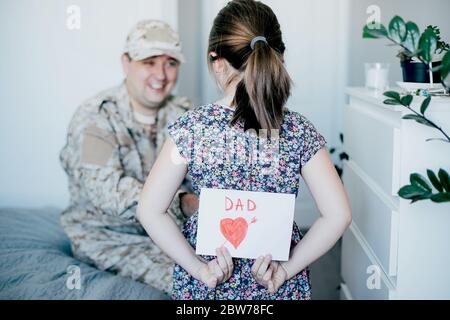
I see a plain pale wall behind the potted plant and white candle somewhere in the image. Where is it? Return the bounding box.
[349,0,450,86]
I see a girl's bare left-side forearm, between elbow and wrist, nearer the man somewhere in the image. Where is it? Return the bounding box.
[139,213,202,279]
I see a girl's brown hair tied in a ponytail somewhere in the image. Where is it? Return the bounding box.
[208,0,291,131]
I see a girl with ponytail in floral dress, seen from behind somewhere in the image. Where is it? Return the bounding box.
[137,0,351,300]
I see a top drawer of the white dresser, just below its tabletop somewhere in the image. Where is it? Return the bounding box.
[344,100,400,196]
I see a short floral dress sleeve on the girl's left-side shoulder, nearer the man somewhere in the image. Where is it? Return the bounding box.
[167,111,193,162]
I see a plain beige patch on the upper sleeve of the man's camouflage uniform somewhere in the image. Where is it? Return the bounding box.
[81,126,116,166]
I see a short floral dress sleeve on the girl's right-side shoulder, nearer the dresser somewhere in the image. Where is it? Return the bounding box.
[300,116,327,168]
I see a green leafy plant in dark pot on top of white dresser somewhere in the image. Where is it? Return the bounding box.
[363,16,450,92]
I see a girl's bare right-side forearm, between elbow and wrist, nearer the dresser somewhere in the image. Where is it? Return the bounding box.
[283,217,351,279]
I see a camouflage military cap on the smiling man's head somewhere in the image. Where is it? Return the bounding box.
[124,20,185,62]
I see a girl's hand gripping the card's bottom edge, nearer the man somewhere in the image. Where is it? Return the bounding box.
[199,247,234,289]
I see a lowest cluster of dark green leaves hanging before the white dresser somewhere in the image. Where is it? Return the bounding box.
[398,169,450,203]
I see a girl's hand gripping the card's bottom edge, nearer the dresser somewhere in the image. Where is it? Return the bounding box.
[252,255,287,294]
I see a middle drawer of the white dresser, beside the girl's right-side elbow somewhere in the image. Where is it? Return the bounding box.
[343,160,399,277]
